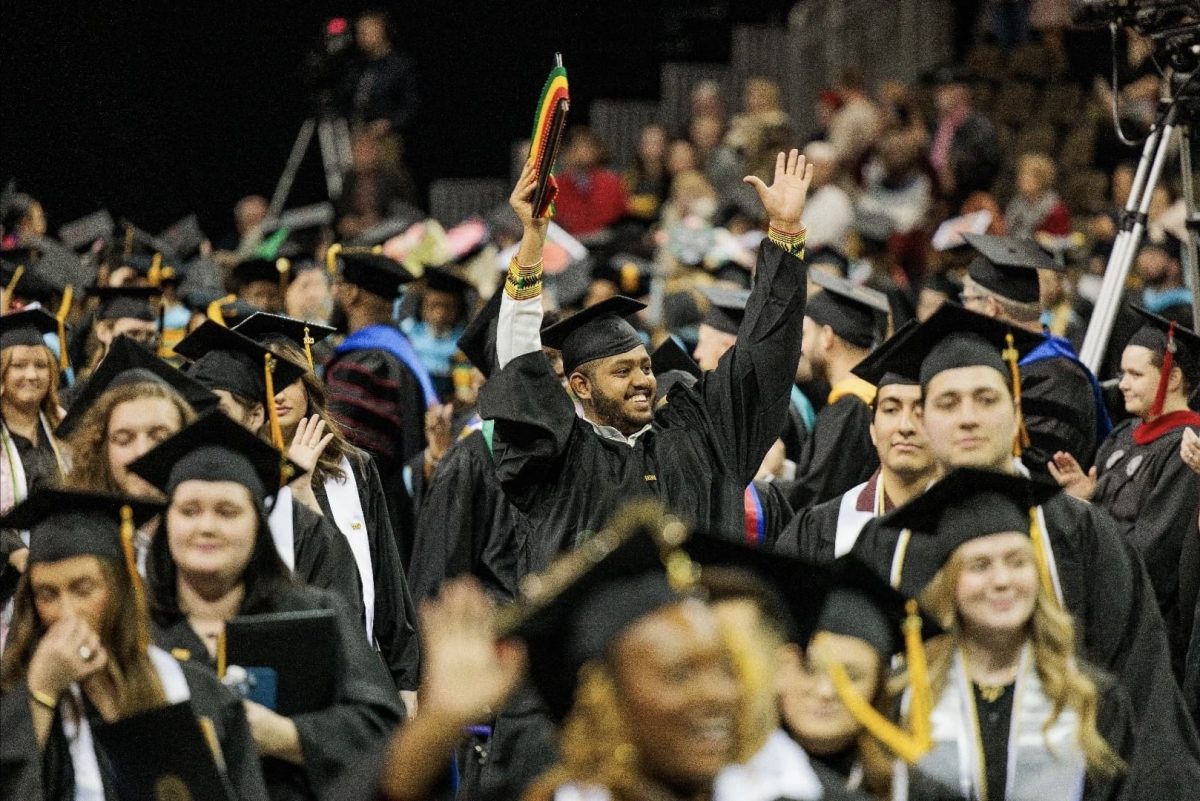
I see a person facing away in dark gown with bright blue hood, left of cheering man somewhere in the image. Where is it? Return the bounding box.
[325,245,438,556]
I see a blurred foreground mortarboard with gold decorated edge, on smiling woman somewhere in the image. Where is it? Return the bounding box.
[498,504,696,722]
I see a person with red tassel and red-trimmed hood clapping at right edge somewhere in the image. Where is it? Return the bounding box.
[1050,306,1200,675]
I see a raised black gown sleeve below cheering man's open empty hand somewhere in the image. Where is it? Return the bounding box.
[696,240,808,486]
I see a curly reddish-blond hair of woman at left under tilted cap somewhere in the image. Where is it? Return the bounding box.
[66,381,196,493]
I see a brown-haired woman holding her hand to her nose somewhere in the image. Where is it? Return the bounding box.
[0,489,268,801]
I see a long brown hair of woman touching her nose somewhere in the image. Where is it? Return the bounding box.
[0,556,167,717]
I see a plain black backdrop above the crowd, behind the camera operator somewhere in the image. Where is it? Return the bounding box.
[0,0,792,242]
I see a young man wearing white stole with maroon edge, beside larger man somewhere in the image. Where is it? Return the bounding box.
[776,321,937,562]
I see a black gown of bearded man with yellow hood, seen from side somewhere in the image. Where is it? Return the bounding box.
[788,395,880,511]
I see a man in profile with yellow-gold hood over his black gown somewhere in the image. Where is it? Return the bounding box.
[790,271,888,510]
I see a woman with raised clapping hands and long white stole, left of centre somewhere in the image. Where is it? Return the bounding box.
[235,312,418,689]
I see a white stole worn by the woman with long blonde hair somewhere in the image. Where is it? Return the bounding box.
[895,645,1086,801]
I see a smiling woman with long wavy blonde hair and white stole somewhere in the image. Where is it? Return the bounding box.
[888,468,1133,800]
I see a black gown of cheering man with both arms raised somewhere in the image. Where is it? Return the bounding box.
[480,242,805,572]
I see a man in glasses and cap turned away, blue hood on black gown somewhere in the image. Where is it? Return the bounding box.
[962,234,1112,475]
